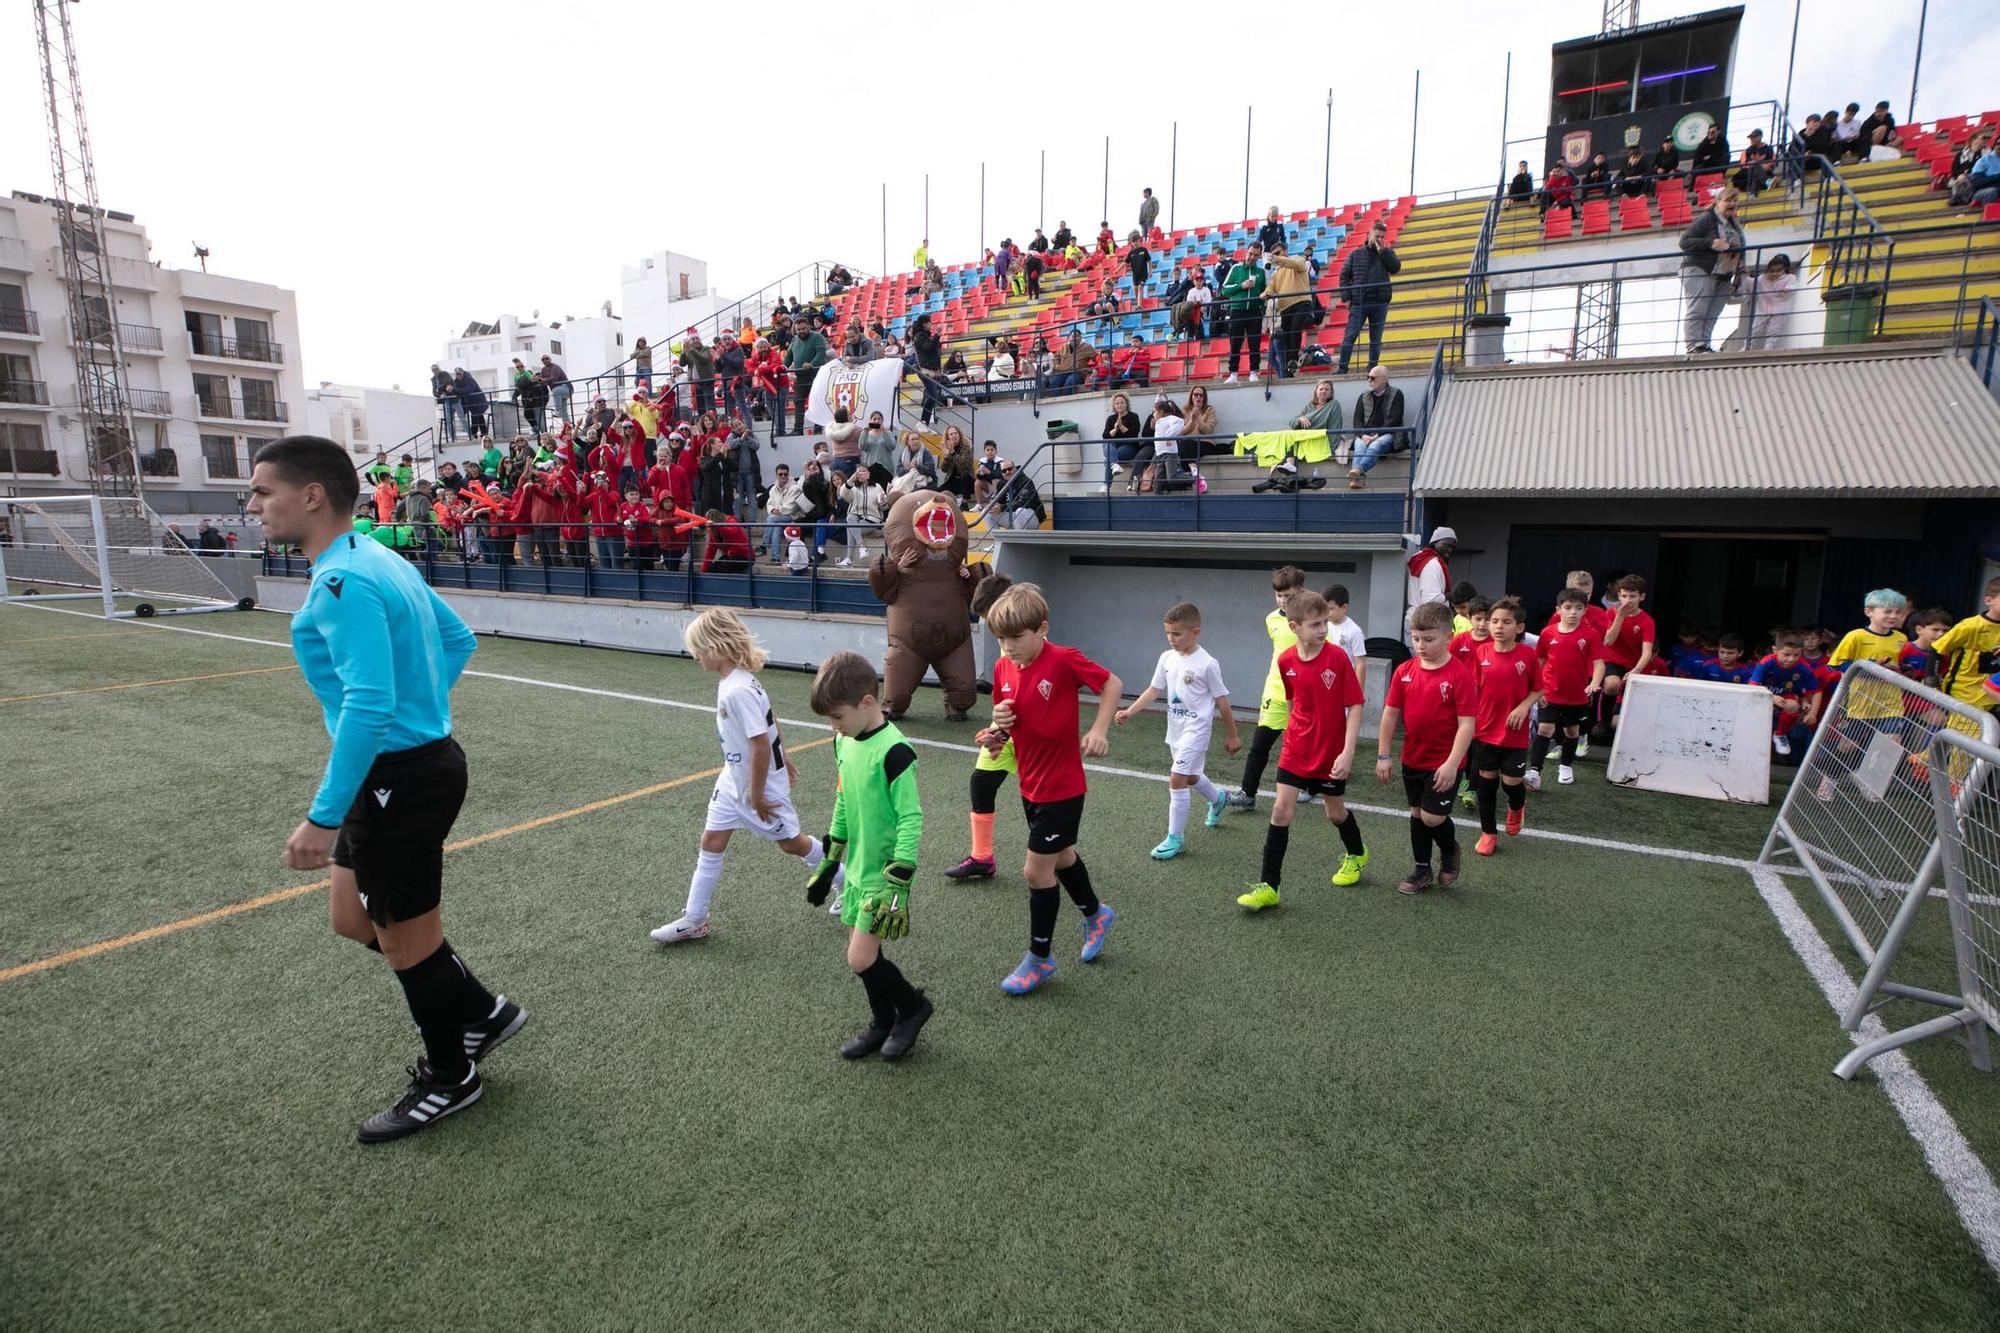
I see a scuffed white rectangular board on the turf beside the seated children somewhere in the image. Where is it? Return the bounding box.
[1606,677,1772,805]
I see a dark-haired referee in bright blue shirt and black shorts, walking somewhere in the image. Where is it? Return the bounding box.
[246,434,528,1143]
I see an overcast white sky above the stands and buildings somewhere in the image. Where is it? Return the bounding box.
[0,0,2000,388]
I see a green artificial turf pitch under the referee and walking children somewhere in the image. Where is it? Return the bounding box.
[0,608,2000,1329]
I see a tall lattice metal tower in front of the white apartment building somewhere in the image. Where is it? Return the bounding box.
[34,0,140,494]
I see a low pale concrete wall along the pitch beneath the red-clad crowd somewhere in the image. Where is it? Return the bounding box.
[256,576,886,669]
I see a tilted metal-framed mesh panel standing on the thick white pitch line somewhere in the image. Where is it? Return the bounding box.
[1758,662,2000,1069]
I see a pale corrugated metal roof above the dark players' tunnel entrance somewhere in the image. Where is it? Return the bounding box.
[1416,348,2000,496]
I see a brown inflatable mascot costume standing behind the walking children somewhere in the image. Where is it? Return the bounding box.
[868,490,988,721]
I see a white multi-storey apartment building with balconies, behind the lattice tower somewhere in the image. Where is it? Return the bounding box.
[0,190,306,514]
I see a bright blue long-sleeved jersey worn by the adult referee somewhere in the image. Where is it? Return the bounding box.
[292,532,476,829]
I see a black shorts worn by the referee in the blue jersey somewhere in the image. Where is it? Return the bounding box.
[334,737,466,925]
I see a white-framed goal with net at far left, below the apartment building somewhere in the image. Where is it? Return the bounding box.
[0,494,250,616]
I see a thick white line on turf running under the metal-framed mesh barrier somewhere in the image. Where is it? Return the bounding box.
[1750,867,2000,1273]
